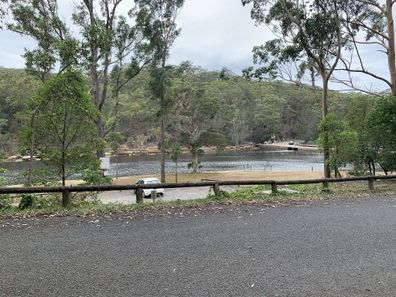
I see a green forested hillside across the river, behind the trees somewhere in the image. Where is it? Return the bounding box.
[0,68,362,153]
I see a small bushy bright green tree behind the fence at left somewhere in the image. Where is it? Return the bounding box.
[21,70,98,184]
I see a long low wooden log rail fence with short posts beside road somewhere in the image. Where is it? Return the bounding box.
[0,175,396,206]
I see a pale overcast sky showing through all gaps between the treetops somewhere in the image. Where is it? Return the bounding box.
[0,0,387,89]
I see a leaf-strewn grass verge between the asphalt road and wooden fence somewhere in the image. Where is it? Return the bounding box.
[0,177,396,219]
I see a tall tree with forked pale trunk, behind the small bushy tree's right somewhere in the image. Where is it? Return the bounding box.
[73,0,150,157]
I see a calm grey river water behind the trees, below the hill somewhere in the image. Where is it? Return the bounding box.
[0,151,323,181]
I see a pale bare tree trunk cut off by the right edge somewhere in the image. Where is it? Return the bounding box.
[386,0,396,96]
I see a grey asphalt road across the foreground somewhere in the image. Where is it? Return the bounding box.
[0,197,396,297]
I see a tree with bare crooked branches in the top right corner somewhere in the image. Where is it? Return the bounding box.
[335,0,396,96]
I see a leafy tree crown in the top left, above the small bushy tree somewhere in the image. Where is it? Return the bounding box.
[7,0,78,83]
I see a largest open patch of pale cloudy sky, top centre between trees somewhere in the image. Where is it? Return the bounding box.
[170,0,272,73]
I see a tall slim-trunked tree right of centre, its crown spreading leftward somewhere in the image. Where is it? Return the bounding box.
[242,0,349,178]
